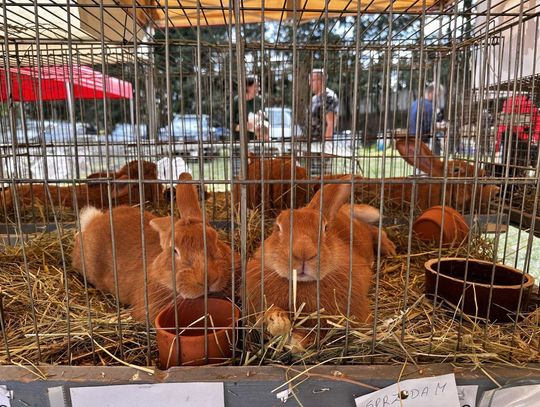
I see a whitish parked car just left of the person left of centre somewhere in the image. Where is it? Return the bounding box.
[158,114,212,142]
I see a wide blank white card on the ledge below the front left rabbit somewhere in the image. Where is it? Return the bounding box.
[70,383,225,407]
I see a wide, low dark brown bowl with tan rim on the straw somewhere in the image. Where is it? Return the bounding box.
[425,258,534,322]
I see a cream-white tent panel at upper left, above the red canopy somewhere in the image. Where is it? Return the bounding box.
[0,0,146,66]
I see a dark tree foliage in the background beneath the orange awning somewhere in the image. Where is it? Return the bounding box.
[154,15,418,132]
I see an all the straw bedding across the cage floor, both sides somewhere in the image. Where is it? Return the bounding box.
[0,194,540,366]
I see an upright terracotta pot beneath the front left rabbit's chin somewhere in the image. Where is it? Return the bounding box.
[155,298,240,369]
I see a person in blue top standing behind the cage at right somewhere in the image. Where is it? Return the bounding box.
[409,84,441,155]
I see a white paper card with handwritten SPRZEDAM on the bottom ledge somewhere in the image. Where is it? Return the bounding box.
[355,373,461,407]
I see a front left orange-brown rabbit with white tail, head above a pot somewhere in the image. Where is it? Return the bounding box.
[72,173,231,323]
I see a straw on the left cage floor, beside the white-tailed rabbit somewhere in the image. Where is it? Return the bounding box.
[0,231,154,365]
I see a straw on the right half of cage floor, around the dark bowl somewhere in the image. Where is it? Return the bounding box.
[246,228,540,364]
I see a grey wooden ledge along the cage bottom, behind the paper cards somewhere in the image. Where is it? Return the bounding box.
[0,364,540,407]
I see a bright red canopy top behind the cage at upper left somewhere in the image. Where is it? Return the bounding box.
[0,65,133,102]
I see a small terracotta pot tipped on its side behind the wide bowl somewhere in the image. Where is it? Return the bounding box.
[413,206,469,246]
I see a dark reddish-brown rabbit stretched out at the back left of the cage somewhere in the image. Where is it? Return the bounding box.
[0,160,162,211]
